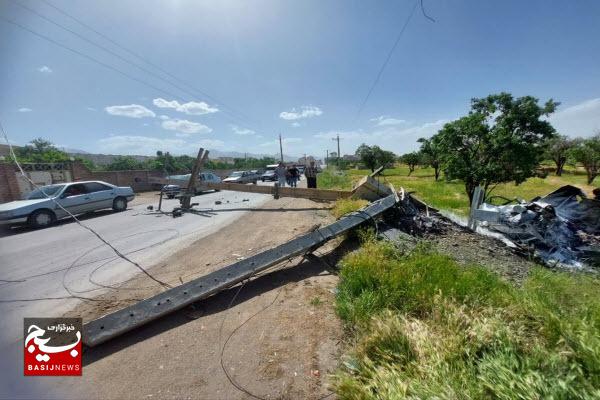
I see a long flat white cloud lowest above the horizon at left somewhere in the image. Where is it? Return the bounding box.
[97,135,225,156]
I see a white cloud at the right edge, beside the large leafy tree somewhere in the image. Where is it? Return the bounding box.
[548,98,600,137]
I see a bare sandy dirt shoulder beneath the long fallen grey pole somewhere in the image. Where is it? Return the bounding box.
[57,199,342,399]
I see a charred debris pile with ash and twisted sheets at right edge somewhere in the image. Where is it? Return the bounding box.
[473,185,600,267]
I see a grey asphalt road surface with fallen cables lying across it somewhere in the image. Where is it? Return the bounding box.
[0,192,270,348]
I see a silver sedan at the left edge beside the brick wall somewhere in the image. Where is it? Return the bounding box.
[0,181,135,228]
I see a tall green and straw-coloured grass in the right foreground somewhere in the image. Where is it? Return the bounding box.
[334,239,600,400]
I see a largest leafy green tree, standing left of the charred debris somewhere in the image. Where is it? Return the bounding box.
[436,93,559,200]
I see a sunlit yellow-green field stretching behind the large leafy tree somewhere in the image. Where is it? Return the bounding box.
[318,165,600,216]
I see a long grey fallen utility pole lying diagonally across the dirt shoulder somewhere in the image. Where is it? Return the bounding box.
[83,193,400,347]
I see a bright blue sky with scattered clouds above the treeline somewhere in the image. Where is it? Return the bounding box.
[0,0,600,157]
